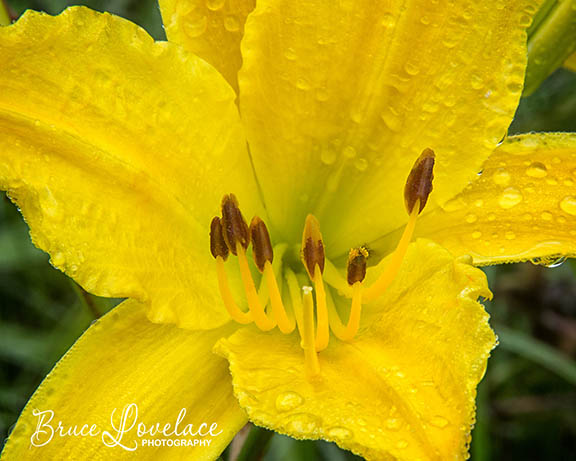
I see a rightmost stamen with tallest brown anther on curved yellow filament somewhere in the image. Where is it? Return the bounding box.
[364,149,434,302]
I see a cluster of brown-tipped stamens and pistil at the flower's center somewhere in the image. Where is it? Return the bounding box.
[210,149,434,376]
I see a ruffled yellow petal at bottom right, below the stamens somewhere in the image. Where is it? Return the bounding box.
[216,241,495,461]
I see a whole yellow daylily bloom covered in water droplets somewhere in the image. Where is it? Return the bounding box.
[0,0,576,460]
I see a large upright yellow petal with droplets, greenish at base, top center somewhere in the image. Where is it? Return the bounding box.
[239,0,537,254]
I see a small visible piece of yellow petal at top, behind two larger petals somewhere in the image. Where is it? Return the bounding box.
[160,0,256,90]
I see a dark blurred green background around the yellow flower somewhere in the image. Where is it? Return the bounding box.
[0,0,576,461]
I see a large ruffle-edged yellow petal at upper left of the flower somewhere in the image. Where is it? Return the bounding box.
[0,8,257,328]
